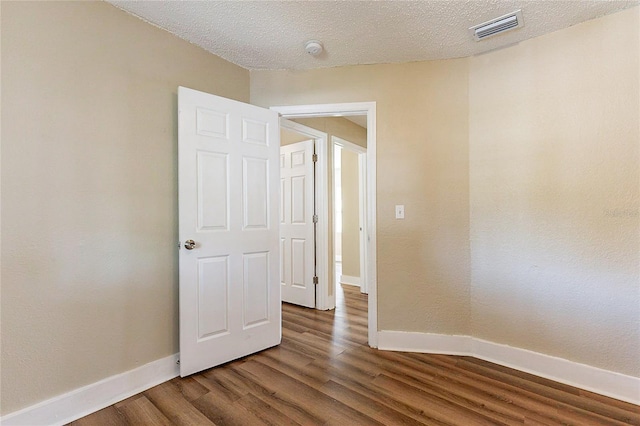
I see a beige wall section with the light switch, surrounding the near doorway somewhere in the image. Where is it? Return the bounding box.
[251,59,470,334]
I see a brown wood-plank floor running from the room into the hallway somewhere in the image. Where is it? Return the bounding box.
[71,286,640,426]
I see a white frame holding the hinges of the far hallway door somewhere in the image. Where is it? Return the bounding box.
[280,117,336,310]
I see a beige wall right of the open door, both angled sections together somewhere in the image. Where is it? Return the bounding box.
[251,8,640,376]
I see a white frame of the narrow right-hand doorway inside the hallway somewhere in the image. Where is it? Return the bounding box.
[330,136,369,293]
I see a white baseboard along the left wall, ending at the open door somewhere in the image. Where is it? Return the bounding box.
[0,354,180,426]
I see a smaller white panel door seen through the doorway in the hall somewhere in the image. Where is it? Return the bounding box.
[280,140,316,308]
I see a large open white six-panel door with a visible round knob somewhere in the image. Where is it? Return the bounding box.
[178,87,282,377]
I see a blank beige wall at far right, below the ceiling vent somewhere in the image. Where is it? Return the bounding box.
[469,7,640,376]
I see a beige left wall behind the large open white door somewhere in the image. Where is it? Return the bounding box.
[1,1,249,414]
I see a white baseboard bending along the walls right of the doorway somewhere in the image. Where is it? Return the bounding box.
[378,331,640,405]
